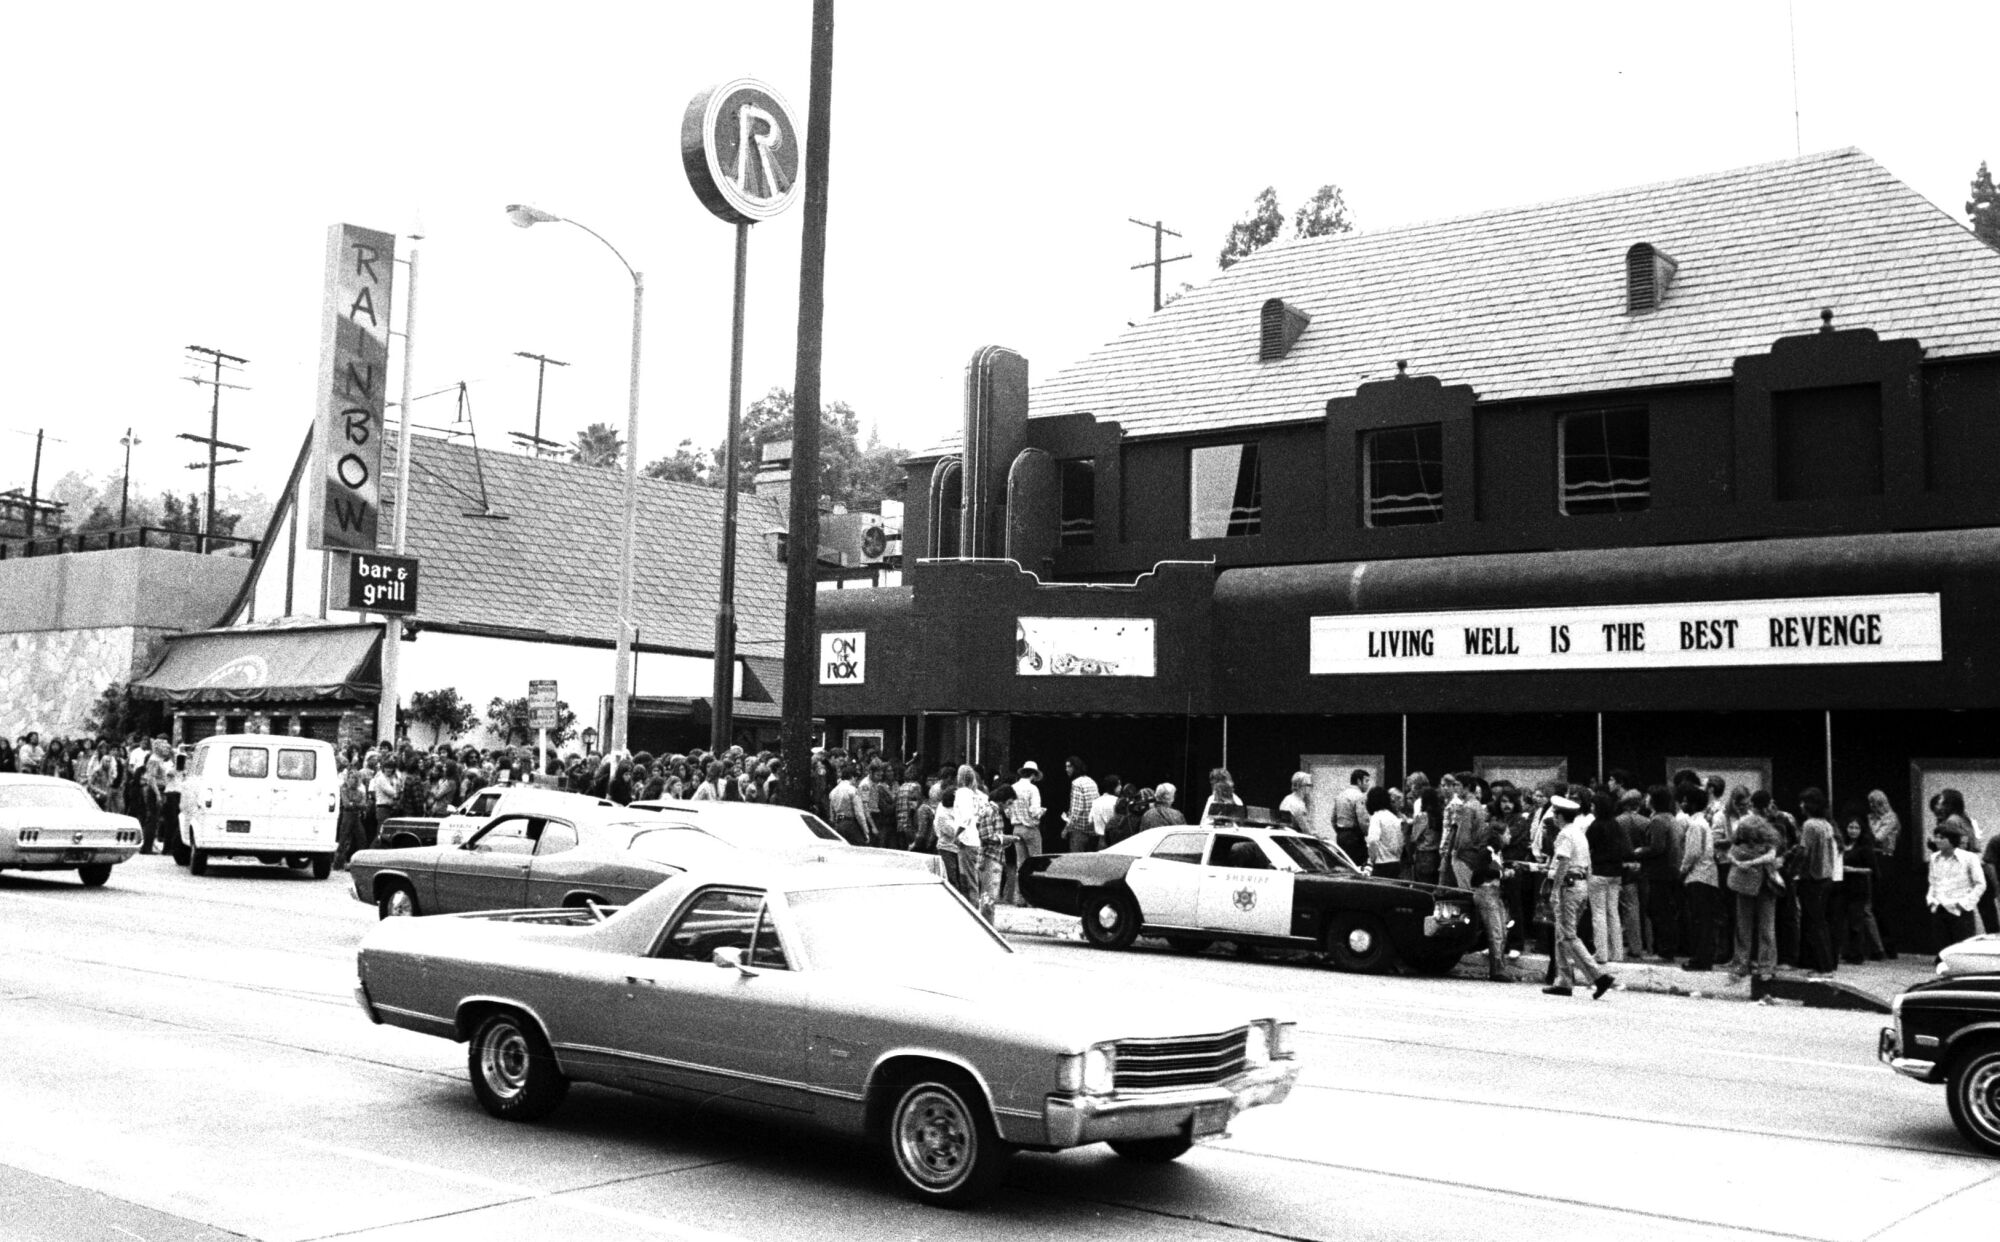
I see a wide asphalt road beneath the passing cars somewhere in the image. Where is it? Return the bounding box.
[0,858,2000,1242]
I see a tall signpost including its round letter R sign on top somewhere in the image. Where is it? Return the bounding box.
[680,78,800,752]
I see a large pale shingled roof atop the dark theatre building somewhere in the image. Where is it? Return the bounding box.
[914,148,2000,458]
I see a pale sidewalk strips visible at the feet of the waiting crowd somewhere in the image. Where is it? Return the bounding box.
[994,906,1936,1012]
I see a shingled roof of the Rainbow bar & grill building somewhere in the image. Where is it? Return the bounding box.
[382,436,786,652]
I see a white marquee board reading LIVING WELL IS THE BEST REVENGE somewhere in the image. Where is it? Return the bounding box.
[1308,594,1944,674]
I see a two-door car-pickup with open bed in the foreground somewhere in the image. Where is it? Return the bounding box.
[354,854,1298,1206]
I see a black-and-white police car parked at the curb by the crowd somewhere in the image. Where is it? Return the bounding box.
[1020,822,1480,974]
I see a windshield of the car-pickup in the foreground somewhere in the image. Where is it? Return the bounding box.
[786,884,1012,970]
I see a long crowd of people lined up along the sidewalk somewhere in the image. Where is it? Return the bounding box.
[0,732,2000,968]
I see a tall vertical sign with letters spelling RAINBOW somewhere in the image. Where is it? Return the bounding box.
[306,224,396,552]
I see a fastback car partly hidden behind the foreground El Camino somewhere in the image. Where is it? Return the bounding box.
[348,806,730,918]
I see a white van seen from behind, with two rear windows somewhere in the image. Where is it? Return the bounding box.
[178,734,340,880]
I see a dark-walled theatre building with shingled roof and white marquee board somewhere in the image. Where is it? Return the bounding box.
[814,150,2000,880]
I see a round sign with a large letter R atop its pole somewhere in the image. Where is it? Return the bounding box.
[680,78,802,224]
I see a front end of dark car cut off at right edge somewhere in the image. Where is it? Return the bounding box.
[1876,968,2000,1156]
